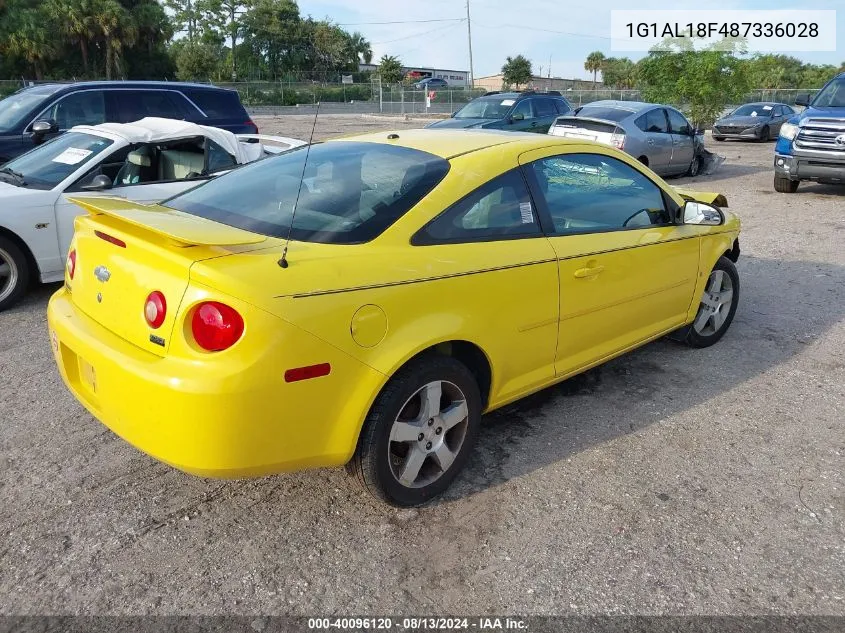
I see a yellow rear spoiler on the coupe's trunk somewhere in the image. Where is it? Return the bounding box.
[68,196,267,246]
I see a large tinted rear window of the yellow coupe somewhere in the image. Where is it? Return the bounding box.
[167,141,449,244]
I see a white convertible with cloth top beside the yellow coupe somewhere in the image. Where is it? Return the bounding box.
[0,118,305,310]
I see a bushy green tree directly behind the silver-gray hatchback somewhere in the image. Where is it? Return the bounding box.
[637,38,749,126]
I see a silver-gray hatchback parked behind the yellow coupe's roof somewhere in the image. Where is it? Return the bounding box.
[549,101,704,176]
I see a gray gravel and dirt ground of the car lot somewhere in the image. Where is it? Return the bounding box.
[0,116,845,615]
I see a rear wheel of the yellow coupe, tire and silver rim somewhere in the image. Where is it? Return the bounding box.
[347,355,482,507]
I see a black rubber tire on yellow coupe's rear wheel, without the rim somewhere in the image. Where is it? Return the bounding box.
[347,354,482,507]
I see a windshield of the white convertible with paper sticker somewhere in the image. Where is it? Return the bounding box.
[4,132,112,189]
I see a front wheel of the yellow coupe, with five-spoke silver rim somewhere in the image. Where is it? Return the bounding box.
[683,256,739,347]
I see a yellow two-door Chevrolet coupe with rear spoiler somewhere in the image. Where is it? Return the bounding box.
[48,130,740,506]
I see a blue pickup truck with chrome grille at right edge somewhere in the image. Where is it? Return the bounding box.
[774,73,845,193]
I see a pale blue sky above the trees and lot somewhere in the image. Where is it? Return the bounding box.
[298,0,845,78]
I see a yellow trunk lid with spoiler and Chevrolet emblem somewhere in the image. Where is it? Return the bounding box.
[66,198,267,356]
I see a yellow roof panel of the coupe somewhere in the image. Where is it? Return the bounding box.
[328,128,584,160]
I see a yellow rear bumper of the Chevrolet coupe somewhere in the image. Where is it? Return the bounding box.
[47,289,384,478]
